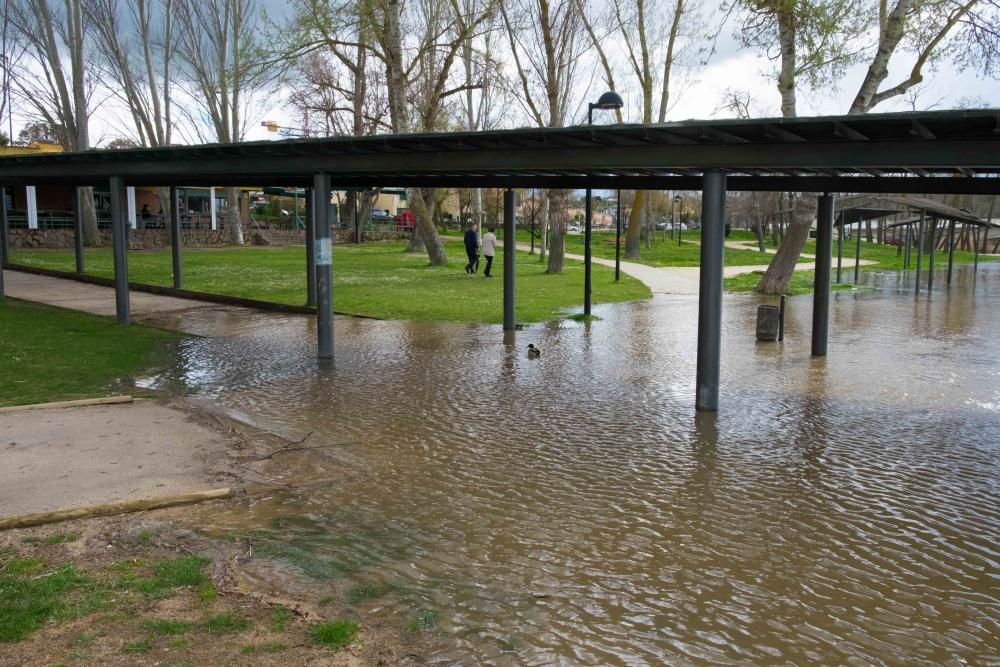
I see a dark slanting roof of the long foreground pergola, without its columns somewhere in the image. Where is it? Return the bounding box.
[0,109,1000,194]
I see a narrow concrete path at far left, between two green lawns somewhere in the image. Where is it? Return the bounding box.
[3,271,218,320]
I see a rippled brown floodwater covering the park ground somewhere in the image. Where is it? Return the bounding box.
[145,266,1000,665]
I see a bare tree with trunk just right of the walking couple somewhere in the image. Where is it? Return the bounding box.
[500,0,585,273]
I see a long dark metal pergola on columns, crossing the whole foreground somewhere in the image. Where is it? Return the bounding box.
[0,109,1000,411]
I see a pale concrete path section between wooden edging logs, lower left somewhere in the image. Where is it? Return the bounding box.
[0,401,229,517]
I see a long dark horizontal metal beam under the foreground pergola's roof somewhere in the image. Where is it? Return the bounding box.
[0,138,1000,183]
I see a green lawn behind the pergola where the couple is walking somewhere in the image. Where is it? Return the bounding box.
[11,241,650,323]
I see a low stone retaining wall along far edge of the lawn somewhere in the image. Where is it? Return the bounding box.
[10,227,410,250]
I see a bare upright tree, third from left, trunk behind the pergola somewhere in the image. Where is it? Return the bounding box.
[175,0,280,244]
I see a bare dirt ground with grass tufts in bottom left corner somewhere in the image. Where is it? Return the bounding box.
[0,516,420,667]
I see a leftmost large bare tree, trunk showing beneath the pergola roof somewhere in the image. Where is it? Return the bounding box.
[4,0,99,246]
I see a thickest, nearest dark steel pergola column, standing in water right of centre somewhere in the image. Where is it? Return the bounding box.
[695,169,726,412]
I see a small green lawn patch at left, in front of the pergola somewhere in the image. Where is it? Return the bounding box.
[0,299,180,406]
